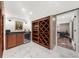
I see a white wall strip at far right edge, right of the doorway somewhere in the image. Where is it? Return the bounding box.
[74,10,79,53]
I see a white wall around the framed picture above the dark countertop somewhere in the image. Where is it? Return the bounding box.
[5,18,29,32]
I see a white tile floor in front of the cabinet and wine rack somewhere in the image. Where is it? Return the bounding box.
[3,42,78,58]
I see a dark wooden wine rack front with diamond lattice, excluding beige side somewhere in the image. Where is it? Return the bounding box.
[32,16,50,48]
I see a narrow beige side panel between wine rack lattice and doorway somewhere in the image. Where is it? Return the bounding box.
[50,16,56,50]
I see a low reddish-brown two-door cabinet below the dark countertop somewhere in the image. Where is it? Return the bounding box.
[6,32,24,49]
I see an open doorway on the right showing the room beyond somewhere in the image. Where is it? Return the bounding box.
[56,13,75,50]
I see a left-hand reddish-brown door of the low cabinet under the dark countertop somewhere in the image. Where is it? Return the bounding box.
[7,34,16,48]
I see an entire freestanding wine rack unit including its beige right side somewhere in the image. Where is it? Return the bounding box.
[32,15,56,49]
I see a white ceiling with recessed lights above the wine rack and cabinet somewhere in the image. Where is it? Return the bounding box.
[4,1,79,20]
